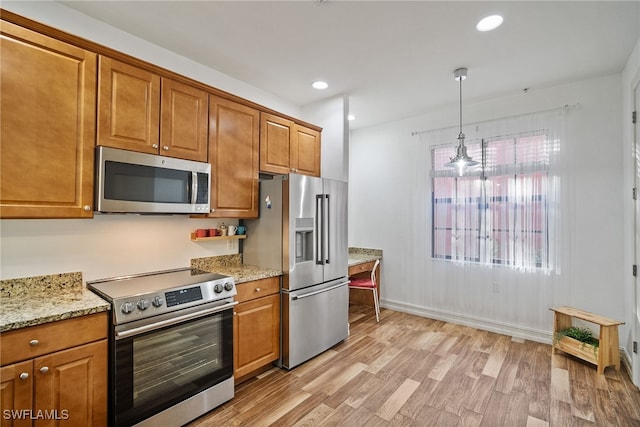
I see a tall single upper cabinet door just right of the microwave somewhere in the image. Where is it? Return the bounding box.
[209,95,260,218]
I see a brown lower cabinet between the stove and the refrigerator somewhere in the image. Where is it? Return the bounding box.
[233,277,280,383]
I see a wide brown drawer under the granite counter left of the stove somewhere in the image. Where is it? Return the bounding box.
[0,312,108,365]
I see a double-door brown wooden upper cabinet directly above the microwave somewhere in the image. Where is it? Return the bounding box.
[97,56,208,162]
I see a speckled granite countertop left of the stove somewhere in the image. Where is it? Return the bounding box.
[0,272,111,332]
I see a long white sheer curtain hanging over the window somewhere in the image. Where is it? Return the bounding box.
[420,107,571,334]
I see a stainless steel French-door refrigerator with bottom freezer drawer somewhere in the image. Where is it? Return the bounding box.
[243,174,349,369]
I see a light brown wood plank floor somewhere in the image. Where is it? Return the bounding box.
[189,305,640,427]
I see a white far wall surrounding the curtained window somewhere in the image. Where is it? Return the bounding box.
[349,75,629,348]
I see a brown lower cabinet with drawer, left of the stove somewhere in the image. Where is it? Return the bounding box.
[0,312,108,427]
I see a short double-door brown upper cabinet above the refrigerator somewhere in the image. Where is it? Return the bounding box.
[260,113,320,176]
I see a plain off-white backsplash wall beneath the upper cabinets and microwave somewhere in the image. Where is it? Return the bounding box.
[0,214,238,281]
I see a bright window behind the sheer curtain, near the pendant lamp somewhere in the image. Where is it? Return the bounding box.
[431,131,550,269]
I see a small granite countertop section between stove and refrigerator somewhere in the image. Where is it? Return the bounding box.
[191,254,282,284]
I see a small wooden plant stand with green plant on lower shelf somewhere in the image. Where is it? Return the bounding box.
[551,307,624,375]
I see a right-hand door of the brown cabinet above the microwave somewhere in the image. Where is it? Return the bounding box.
[160,78,208,162]
